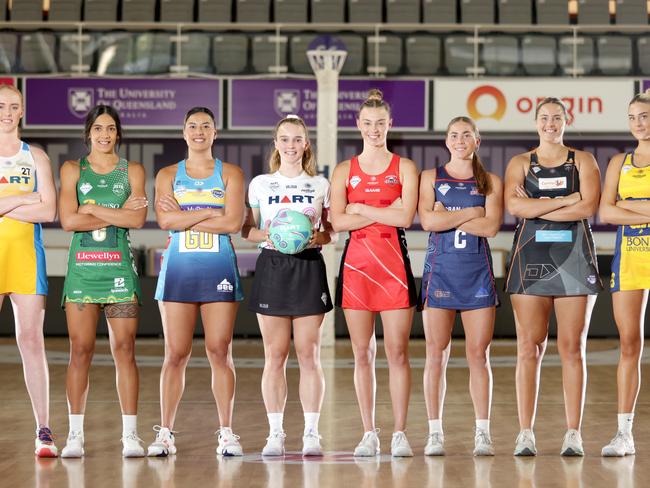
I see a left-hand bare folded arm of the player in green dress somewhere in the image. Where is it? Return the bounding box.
[59,161,109,232]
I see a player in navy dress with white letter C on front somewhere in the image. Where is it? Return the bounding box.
[418,117,503,456]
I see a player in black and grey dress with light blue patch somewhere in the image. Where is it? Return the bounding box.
[504,98,602,456]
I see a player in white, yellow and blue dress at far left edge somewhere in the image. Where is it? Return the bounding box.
[0,85,57,457]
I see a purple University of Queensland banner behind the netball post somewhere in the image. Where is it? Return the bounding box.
[228,79,429,131]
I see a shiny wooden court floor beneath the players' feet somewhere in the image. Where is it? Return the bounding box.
[0,338,650,488]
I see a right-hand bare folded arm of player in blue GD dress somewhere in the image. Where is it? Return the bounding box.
[192,163,246,234]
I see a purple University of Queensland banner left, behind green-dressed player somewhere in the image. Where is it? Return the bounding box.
[24,78,222,129]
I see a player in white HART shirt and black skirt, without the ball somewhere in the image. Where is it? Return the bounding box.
[242,115,333,456]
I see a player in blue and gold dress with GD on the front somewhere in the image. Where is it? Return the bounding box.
[148,107,244,456]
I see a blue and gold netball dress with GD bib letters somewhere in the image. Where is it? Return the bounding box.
[156,159,243,302]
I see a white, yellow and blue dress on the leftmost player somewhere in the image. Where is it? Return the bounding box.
[0,142,47,295]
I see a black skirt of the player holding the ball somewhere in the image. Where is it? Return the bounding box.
[248,249,333,316]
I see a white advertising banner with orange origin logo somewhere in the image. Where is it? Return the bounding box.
[433,78,634,133]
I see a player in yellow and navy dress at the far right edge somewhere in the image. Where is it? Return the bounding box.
[600,90,650,456]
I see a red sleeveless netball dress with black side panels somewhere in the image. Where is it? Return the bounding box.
[336,154,416,312]
